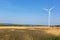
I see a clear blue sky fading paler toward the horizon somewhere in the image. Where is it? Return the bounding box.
[0,0,60,25]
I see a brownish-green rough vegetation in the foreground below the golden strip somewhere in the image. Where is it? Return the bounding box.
[0,29,60,40]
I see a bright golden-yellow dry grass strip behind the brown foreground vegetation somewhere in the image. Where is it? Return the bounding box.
[0,26,60,35]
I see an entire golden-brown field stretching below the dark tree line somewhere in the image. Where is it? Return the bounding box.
[0,26,60,40]
